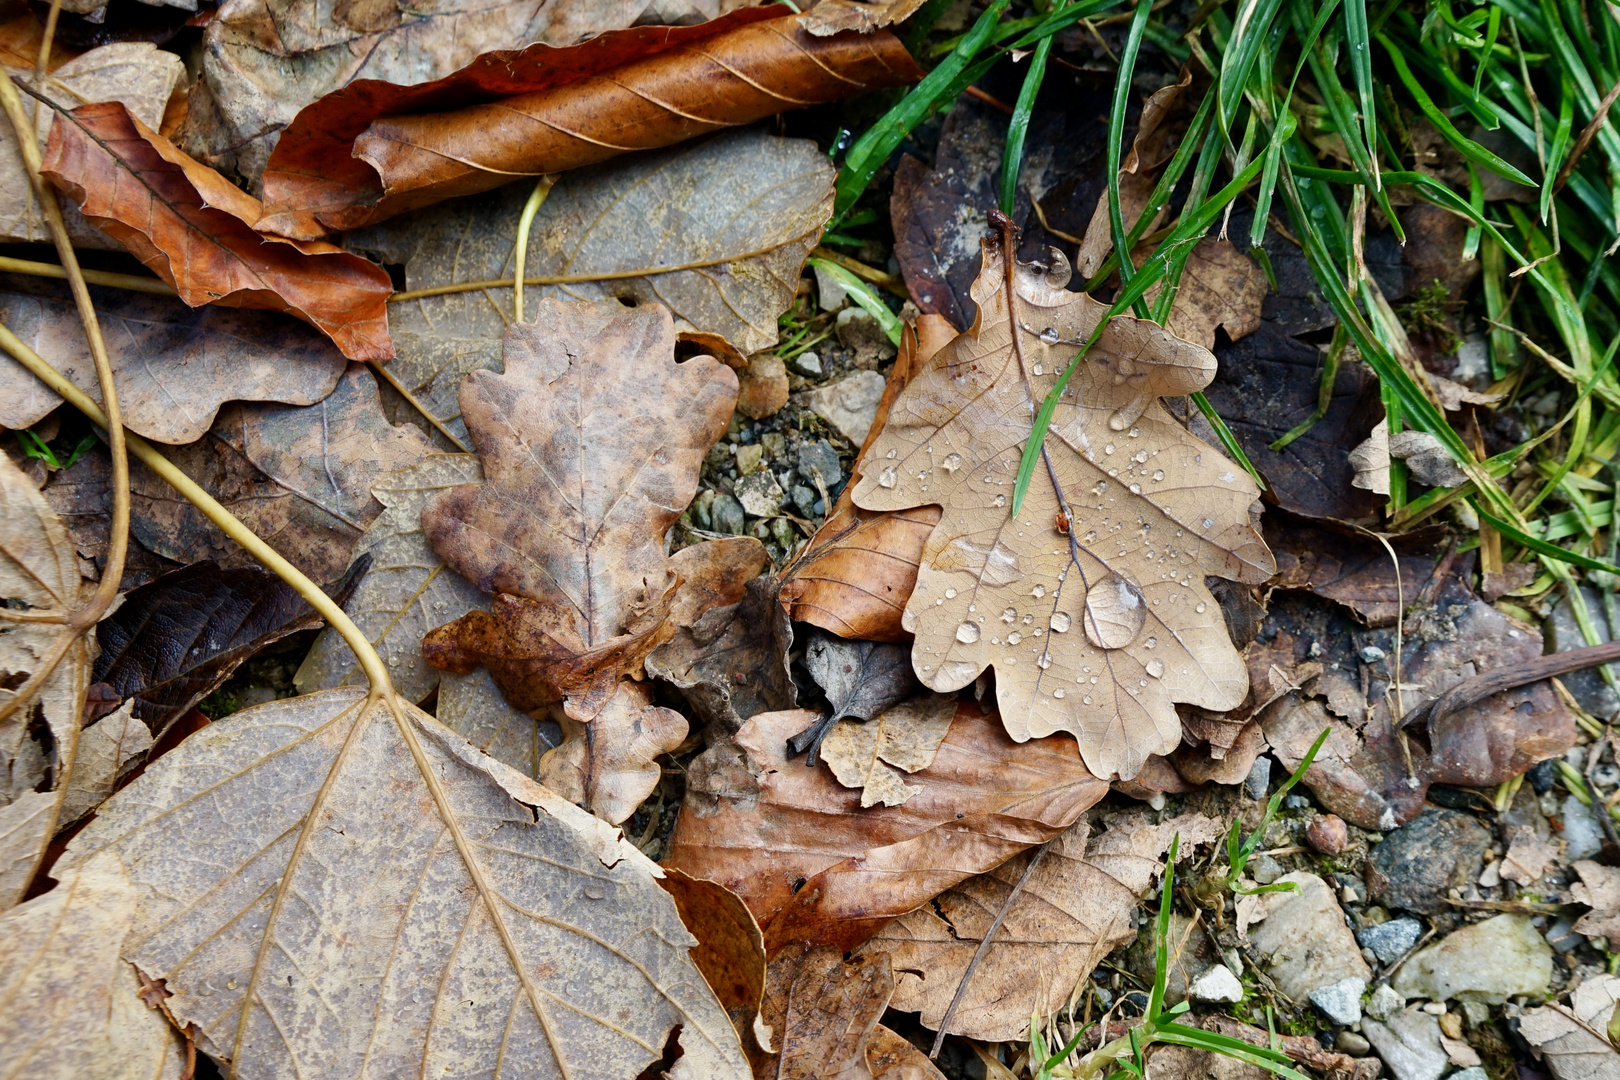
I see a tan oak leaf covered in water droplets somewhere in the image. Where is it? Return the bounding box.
[854,241,1275,779]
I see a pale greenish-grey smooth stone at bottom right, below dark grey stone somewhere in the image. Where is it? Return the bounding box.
[1393,915,1552,1006]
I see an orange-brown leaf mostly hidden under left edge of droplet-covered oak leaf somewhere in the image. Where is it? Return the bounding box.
[781,314,956,641]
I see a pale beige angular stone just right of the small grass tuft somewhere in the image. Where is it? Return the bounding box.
[1249,873,1372,1001]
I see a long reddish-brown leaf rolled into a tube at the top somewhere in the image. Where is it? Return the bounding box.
[261,8,922,234]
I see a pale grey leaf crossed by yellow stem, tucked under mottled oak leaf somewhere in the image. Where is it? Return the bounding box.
[293,453,486,702]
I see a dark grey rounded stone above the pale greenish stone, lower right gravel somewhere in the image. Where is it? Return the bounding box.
[1367,810,1490,915]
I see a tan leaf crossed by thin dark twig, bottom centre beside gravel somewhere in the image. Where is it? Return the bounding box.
[862,813,1221,1043]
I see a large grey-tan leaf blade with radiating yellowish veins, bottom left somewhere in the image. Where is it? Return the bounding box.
[58,688,748,1080]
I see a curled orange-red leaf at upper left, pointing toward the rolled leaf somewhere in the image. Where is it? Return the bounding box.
[42,102,394,359]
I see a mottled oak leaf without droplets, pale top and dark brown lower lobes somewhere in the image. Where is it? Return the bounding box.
[421,300,737,722]
